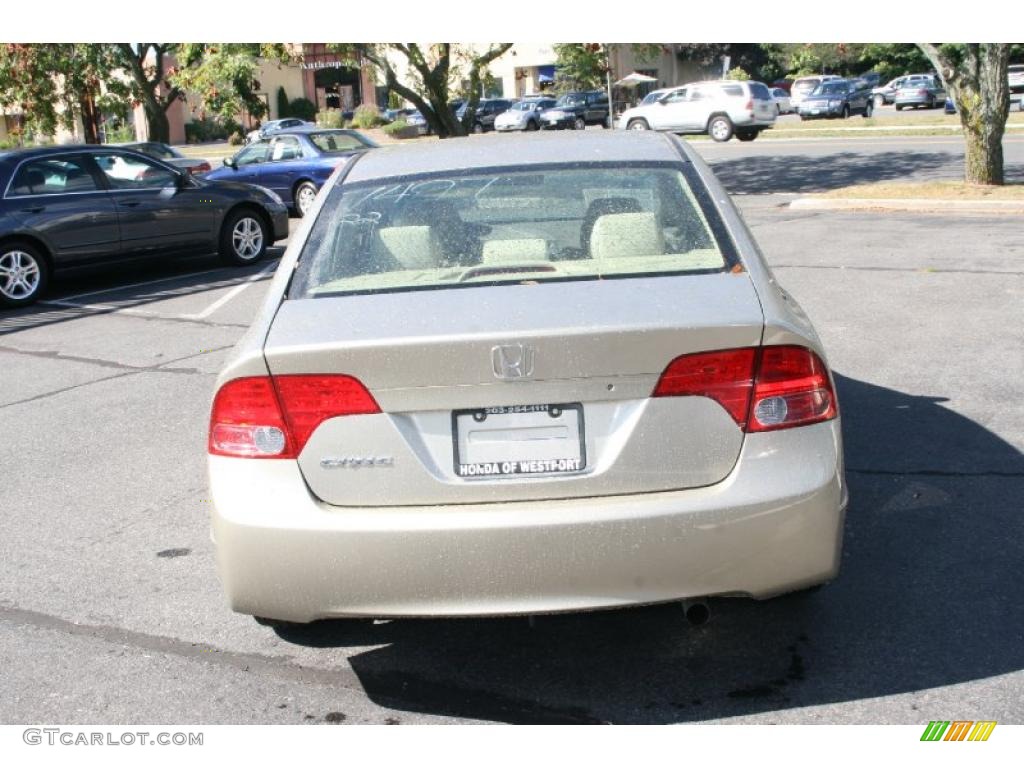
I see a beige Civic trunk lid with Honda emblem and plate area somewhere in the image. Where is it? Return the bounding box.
[265,272,763,506]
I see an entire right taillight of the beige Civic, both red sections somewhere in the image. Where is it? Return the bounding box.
[652,346,837,432]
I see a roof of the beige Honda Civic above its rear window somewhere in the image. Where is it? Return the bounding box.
[345,131,686,183]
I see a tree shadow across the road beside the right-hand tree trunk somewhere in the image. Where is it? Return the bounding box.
[712,150,964,195]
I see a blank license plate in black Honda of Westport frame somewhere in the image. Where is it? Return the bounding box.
[452,402,587,479]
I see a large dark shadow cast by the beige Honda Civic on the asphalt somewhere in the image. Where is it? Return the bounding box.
[279,376,1024,723]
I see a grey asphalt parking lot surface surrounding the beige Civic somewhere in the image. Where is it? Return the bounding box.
[0,137,1024,724]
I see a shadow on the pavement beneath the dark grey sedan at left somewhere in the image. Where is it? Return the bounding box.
[0,252,285,336]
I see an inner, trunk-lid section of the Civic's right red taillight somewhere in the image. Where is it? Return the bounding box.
[653,347,756,429]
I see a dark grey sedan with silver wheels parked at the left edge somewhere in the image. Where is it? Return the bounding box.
[0,145,288,307]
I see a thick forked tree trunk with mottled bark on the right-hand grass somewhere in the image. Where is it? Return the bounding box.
[918,43,1011,184]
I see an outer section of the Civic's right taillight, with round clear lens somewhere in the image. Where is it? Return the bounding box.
[746,346,837,432]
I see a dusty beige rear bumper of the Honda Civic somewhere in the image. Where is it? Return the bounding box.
[210,420,847,622]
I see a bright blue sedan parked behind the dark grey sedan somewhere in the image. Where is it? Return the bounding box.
[204,126,378,216]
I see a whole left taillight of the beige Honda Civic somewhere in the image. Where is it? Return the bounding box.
[208,375,380,459]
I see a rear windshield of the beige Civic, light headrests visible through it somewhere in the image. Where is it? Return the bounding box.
[291,165,726,298]
